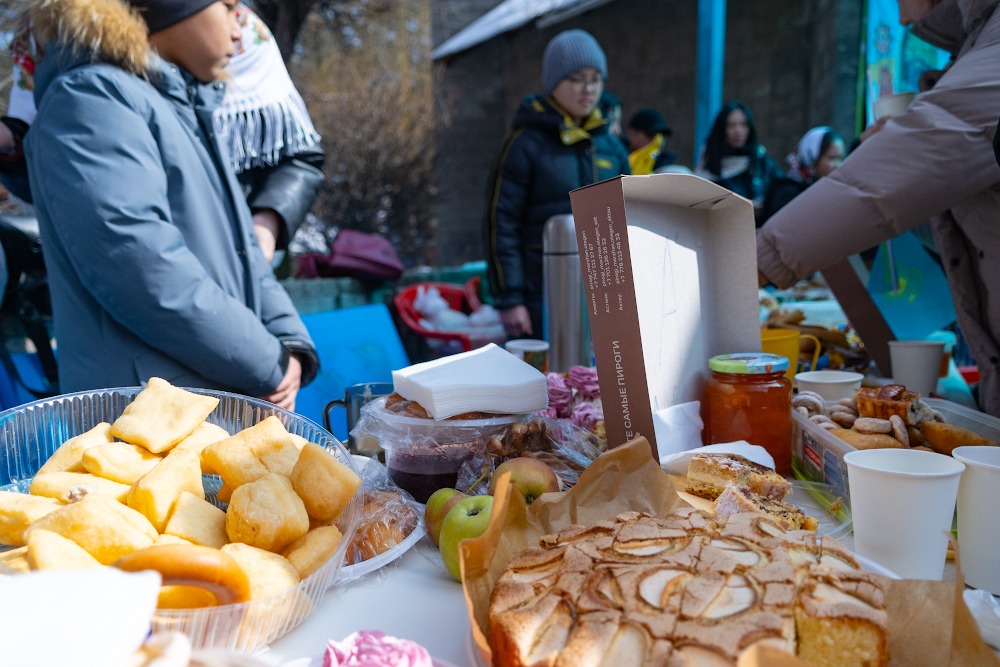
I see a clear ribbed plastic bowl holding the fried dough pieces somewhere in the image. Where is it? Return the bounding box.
[0,387,361,651]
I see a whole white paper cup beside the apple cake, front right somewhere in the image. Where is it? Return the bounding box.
[844,449,965,580]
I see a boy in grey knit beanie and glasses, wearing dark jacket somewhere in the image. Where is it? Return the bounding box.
[483,30,630,338]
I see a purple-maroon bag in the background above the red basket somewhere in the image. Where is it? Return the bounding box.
[298,229,403,280]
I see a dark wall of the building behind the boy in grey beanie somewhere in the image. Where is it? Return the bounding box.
[433,0,861,265]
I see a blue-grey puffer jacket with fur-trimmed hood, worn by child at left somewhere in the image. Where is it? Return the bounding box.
[26,0,315,396]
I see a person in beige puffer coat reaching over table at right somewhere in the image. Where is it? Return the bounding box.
[757,0,1000,417]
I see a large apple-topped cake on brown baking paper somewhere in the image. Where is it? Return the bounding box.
[489,508,889,667]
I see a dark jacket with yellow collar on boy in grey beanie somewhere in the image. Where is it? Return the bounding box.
[484,95,630,335]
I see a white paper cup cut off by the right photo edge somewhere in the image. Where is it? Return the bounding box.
[951,446,1000,595]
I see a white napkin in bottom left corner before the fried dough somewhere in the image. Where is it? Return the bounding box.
[0,567,160,667]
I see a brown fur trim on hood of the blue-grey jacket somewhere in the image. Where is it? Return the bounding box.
[28,0,151,74]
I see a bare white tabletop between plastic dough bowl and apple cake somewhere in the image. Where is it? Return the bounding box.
[260,537,477,667]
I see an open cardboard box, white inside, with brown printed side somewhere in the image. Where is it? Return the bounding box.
[570,174,761,454]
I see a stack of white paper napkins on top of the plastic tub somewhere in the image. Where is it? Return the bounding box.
[392,343,549,419]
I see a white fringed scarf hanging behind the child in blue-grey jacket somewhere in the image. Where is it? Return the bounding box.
[214,5,320,174]
